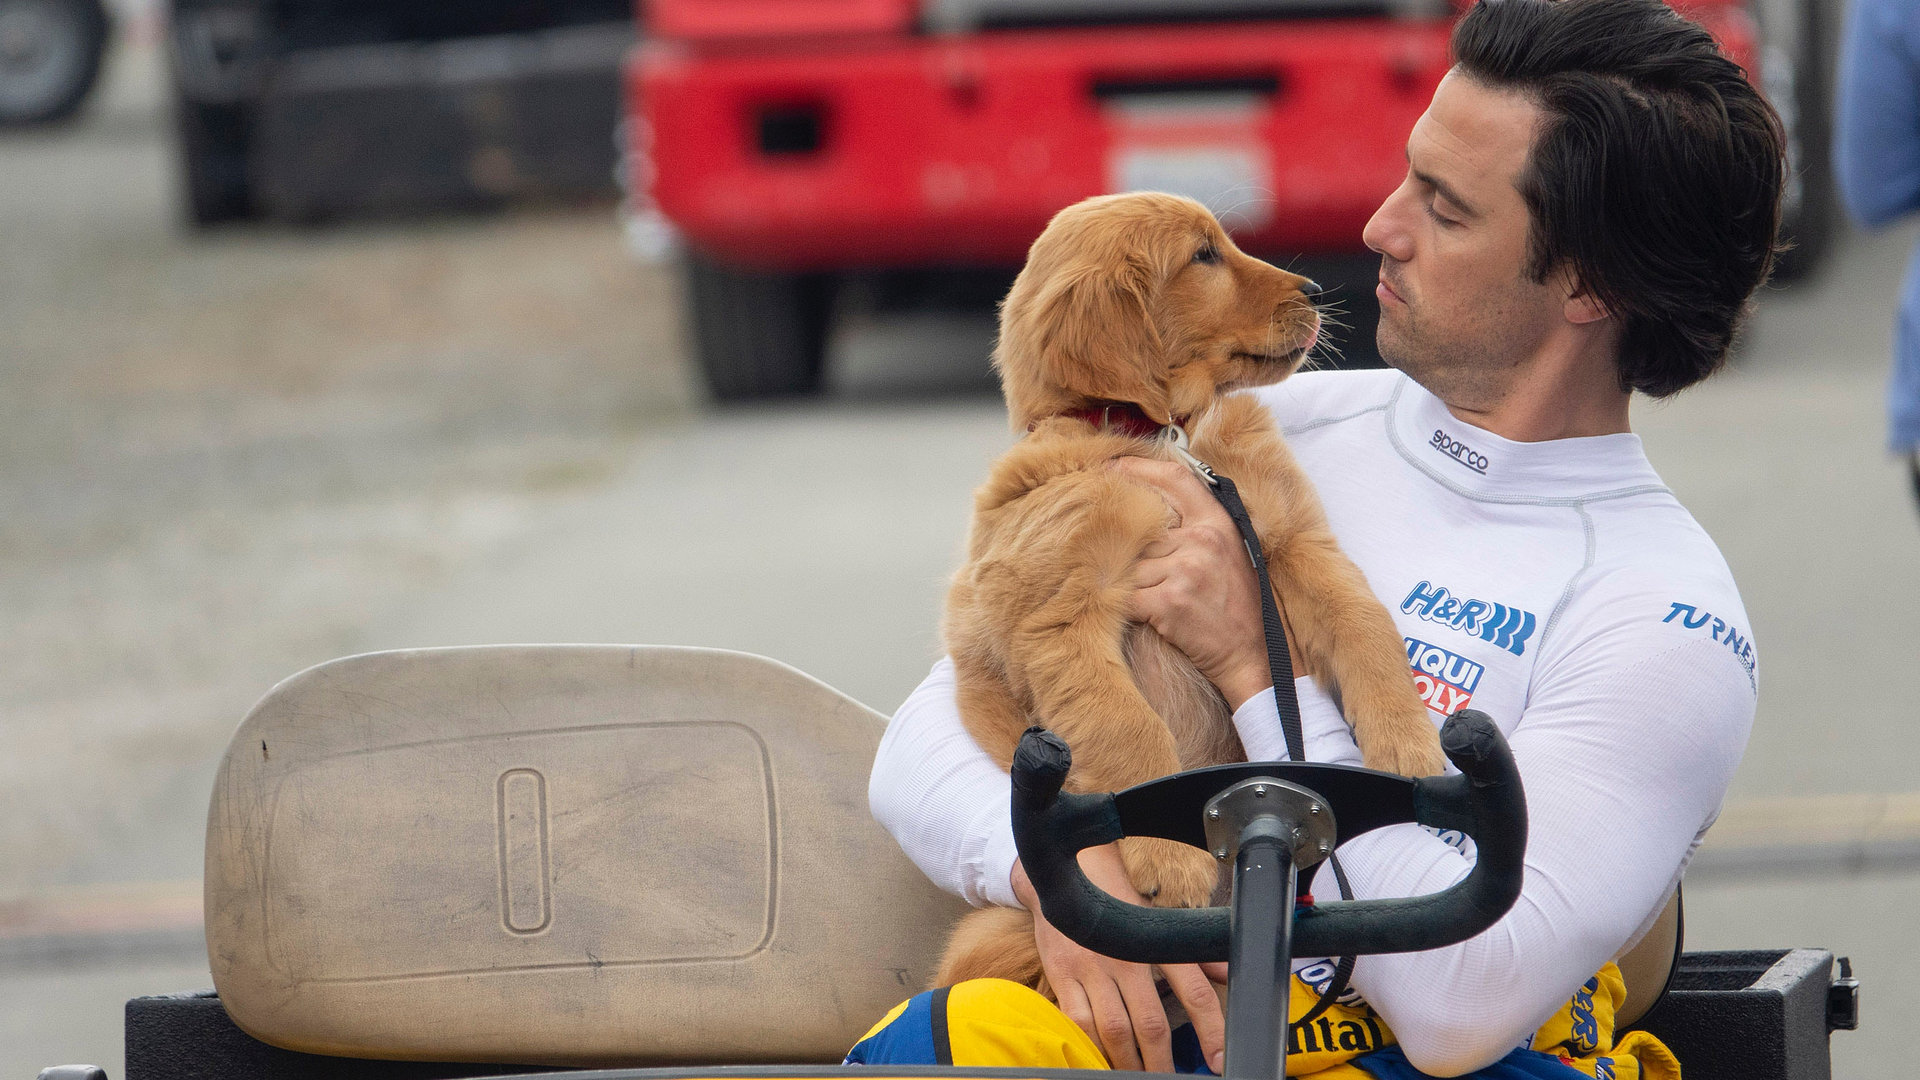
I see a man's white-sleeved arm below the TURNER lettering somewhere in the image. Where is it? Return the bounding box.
[1340,626,1753,1076]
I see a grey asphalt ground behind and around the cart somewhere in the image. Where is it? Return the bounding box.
[0,16,1920,1078]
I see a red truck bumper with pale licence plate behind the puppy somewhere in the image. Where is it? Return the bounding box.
[626,4,1755,271]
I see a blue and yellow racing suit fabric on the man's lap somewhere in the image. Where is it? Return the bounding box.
[847,963,1680,1080]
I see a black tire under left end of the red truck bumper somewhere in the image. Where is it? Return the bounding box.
[685,252,833,402]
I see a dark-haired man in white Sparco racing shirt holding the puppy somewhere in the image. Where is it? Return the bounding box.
[870,0,1784,1076]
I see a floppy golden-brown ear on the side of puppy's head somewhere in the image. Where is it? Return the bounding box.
[993,254,1171,430]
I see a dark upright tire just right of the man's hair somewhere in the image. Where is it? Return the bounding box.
[1761,0,1836,282]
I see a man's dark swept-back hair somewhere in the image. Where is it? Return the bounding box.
[1453,0,1786,398]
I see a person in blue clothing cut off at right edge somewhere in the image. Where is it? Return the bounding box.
[1834,0,1920,515]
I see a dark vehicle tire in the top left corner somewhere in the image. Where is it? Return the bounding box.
[0,0,109,127]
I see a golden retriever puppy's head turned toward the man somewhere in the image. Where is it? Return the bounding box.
[993,192,1319,430]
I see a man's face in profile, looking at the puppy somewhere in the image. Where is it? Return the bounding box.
[1361,69,1567,409]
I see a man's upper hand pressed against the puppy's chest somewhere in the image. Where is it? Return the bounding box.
[1110,457,1273,709]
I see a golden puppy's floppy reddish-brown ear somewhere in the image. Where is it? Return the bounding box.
[1023,256,1171,425]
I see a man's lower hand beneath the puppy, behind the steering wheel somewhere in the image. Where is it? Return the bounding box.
[1012,844,1227,1074]
